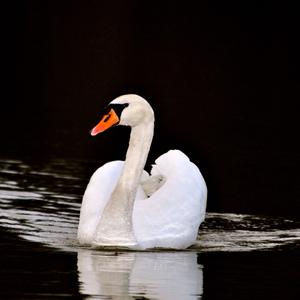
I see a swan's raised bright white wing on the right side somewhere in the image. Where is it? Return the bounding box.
[133,150,207,249]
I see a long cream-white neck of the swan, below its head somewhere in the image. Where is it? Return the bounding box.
[96,120,154,247]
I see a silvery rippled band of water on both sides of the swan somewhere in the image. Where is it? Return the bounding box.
[0,160,300,252]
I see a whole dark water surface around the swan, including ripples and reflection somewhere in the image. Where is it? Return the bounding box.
[0,159,300,299]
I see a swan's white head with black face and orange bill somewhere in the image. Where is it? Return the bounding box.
[91,94,154,136]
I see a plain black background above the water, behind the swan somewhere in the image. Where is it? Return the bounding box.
[0,0,300,216]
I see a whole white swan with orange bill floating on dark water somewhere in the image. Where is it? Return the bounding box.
[78,94,207,250]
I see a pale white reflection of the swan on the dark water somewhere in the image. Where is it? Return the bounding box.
[78,249,203,300]
